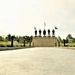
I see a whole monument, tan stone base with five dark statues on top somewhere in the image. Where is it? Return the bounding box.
[32,29,58,47]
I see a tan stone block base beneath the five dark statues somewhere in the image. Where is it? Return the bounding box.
[32,37,58,47]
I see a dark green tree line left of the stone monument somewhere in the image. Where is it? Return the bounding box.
[0,34,33,43]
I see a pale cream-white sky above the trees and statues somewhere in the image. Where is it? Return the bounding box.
[0,0,75,38]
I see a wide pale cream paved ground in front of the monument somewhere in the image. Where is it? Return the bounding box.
[0,47,75,75]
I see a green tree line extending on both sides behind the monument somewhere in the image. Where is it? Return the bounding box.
[0,34,75,43]
